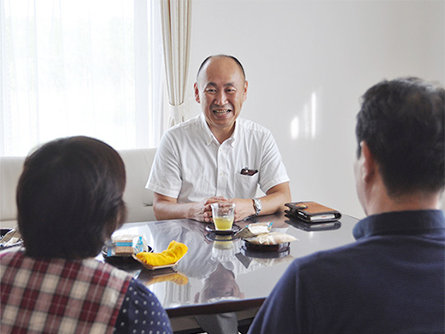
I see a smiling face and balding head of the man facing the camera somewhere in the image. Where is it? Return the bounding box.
[195,56,247,133]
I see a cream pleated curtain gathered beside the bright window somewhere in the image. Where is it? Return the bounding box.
[161,0,191,126]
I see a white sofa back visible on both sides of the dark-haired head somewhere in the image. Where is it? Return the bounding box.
[0,148,156,228]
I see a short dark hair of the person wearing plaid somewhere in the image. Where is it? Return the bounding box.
[17,136,126,259]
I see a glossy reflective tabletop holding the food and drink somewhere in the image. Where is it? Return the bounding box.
[103,213,358,316]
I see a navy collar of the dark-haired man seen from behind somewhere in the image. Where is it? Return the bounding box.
[353,210,445,239]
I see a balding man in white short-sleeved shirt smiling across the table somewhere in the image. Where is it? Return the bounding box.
[146,55,291,222]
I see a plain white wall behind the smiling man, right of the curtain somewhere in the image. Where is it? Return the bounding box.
[184,0,445,217]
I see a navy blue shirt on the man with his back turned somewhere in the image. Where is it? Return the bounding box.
[249,210,445,334]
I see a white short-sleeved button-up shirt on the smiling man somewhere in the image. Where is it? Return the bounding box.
[146,114,289,203]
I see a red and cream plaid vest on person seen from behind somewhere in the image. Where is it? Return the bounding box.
[0,251,131,333]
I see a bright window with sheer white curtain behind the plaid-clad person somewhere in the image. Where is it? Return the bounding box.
[0,0,164,155]
